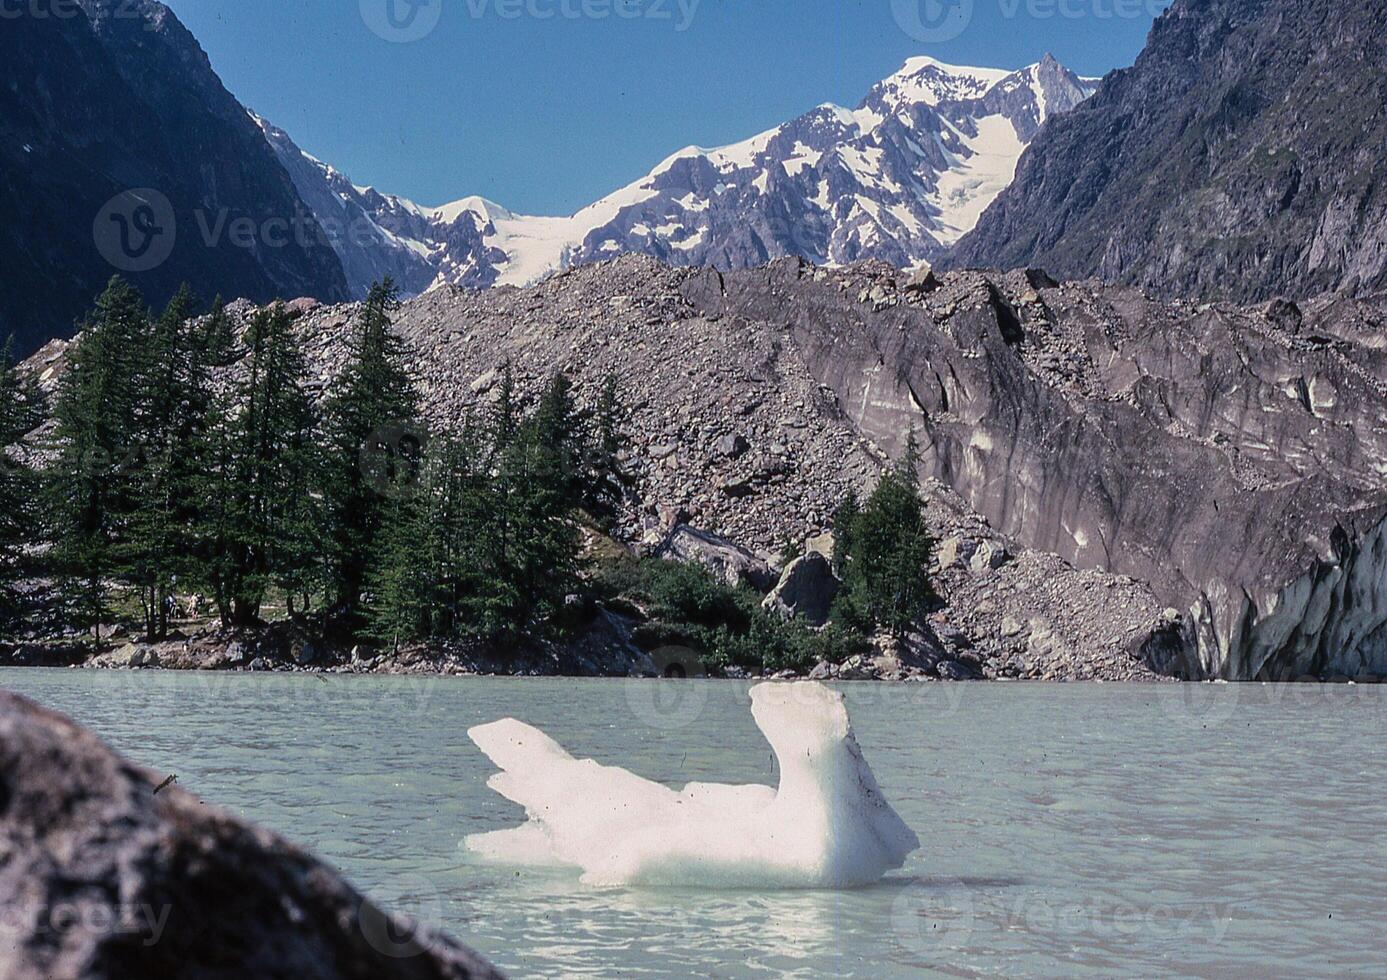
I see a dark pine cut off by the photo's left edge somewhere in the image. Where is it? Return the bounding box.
[0,342,40,635]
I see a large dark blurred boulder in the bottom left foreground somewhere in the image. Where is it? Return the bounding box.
[0,690,501,980]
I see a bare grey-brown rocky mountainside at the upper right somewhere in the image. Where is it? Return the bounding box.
[947,0,1387,302]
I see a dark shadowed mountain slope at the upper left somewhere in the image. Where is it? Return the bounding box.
[0,0,347,351]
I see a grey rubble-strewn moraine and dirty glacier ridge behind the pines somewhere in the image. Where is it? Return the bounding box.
[29,256,1387,678]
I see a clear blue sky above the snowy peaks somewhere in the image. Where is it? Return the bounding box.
[165,0,1162,213]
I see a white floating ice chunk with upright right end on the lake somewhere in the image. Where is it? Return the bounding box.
[463,682,920,889]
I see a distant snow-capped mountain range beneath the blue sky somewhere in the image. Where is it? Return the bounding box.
[257,55,1097,294]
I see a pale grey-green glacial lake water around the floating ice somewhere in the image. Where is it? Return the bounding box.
[0,670,1387,979]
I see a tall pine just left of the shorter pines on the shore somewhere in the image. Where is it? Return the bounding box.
[323,279,422,628]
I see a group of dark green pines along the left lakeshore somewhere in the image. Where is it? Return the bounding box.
[0,277,621,643]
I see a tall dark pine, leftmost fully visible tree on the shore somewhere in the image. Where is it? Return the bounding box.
[46,277,150,639]
